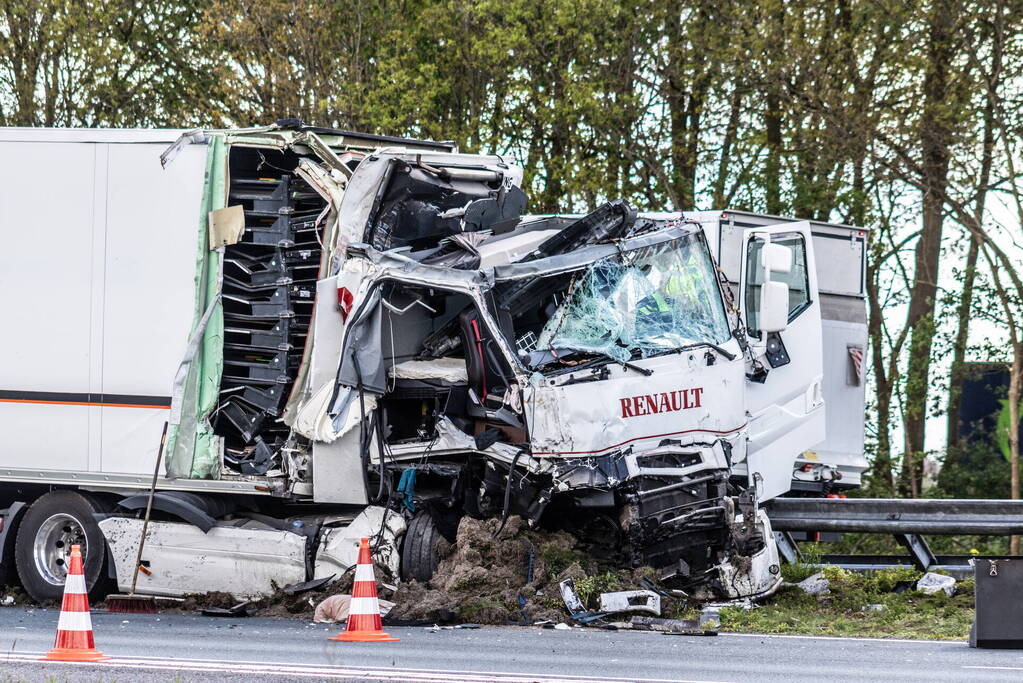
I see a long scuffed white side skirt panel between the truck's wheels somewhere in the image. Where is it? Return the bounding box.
[99,517,306,599]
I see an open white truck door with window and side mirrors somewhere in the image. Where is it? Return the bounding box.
[740,221,822,500]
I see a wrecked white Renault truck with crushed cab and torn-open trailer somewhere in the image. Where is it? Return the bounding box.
[0,122,855,600]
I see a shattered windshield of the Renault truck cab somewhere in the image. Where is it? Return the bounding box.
[537,235,730,362]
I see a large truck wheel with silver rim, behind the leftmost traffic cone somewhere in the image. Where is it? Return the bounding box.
[14,491,107,602]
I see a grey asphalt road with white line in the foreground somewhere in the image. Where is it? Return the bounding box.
[0,607,1023,683]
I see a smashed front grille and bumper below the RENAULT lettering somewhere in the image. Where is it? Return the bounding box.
[553,440,781,599]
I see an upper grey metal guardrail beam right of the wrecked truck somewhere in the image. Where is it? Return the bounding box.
[764,498,1023,536]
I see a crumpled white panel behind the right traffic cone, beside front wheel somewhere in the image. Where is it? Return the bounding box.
[313,505,405,578]
